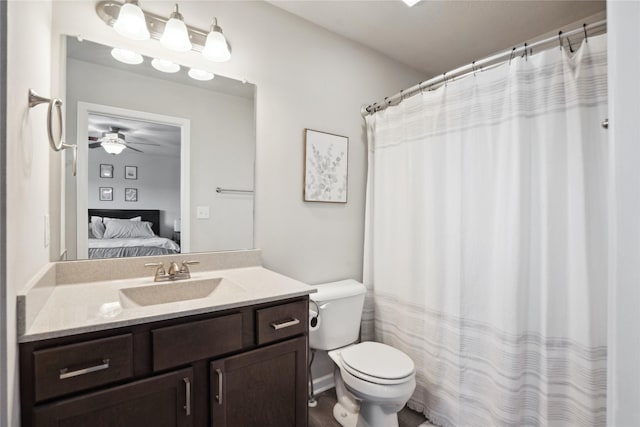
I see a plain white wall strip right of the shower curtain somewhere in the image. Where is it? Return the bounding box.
[607,1,640,427]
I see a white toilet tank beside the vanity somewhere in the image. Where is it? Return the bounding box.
[309,279,365,350]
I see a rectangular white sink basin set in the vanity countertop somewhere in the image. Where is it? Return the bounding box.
[119,278,246,308]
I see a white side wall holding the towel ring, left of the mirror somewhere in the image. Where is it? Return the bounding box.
[5,1,53,425]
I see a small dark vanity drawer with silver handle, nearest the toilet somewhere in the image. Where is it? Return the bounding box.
[256,300,309,344]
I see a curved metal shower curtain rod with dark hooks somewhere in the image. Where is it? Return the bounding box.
[360,19,607,117]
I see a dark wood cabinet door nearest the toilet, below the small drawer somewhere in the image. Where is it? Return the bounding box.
[210,336,307,427]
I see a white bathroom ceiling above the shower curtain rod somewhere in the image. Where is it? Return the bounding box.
[270,0,606,78]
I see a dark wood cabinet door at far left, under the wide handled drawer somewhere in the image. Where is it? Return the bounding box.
[34,368,193,427]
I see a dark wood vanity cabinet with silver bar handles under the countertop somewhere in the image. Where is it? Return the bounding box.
[20,296,308,427]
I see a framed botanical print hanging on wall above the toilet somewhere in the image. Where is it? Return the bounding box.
[304,129,349,203]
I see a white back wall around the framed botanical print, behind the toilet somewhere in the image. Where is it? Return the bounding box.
[54,0,423,283]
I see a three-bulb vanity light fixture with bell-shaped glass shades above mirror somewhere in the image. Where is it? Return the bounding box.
[96,0,231,62]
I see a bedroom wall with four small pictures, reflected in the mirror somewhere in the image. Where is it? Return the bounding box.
[85,150,180,239]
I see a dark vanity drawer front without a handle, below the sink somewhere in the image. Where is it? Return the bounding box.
[151,313,242,371]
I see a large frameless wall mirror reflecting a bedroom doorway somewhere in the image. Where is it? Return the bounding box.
[63,37,256,260]
